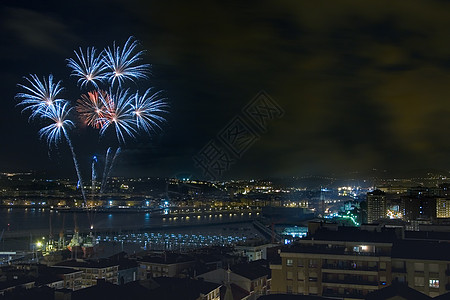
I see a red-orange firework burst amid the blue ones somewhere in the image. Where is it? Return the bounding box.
[76,90,109,129]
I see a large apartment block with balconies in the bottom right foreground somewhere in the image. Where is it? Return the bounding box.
[271,228,450,299]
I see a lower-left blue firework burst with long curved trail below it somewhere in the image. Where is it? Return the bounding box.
[39,102,86,204]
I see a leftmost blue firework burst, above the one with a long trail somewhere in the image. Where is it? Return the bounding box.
[16,74,66,119]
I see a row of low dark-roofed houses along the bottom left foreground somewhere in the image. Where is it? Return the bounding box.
[0,248,270,300]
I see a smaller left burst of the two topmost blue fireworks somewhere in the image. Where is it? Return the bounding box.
[67,47,106,88]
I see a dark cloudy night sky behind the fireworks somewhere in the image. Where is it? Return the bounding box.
[0,0,450,177]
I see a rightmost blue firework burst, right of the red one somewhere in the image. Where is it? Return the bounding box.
[131,89,167,134]
